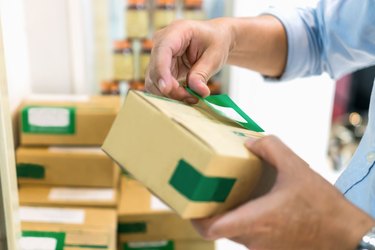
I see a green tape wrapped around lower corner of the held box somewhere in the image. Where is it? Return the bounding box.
[169,160,236,202]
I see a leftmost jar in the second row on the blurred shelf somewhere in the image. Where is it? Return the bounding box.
[113,40,134,81]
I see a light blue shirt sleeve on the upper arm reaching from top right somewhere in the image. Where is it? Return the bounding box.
[263,0,375,80]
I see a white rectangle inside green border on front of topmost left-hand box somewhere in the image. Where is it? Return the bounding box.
[28,107,70,127]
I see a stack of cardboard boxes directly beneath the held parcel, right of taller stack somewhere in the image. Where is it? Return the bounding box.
[118,177,215,250]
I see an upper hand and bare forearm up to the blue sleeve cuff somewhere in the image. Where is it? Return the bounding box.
[145,16,287,103]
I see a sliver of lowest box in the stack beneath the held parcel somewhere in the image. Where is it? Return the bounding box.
[119,240,215,250]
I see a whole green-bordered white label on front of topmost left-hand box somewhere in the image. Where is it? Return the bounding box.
[22,106,76,134]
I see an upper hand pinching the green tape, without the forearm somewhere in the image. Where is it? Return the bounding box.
[146,18,233,103]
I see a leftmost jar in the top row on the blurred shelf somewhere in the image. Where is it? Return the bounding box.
[125,0,149,39]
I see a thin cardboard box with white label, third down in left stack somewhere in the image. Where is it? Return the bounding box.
[18,184,119,208]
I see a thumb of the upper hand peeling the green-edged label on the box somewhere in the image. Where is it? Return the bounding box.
[187,49,221,97]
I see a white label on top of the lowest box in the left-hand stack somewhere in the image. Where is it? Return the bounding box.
[19,207,85,224]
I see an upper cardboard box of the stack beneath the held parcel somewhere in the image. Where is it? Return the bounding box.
[118,177,202,242]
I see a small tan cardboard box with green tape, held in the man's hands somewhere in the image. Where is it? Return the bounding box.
[102,91,275,218]
